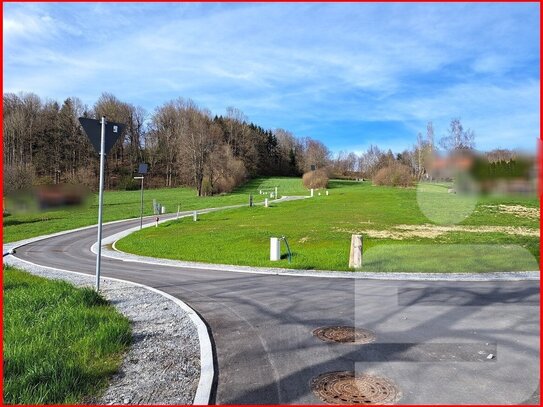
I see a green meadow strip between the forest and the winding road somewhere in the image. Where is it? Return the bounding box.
[3,178,307,242]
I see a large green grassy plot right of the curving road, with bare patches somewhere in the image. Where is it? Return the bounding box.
[117,180,539,272]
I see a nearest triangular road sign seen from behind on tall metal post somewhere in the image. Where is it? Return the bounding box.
[79,116,124,291]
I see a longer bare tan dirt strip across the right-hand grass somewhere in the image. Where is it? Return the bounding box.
[335,224,539,240]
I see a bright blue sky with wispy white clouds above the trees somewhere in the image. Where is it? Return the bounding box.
[3,3,540,152]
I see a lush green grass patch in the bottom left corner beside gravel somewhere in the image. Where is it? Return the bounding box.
[4,267,131,404]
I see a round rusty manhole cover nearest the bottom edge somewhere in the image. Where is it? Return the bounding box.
[311,372,402,404]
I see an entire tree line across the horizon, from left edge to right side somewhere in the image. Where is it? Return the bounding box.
[3,93,527,195]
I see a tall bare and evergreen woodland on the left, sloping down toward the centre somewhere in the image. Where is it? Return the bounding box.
[3,93,330,195]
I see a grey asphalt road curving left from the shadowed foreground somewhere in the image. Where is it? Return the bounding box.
[12,215,539,404]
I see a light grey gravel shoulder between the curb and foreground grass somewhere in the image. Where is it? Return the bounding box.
[4,256,200,405]
